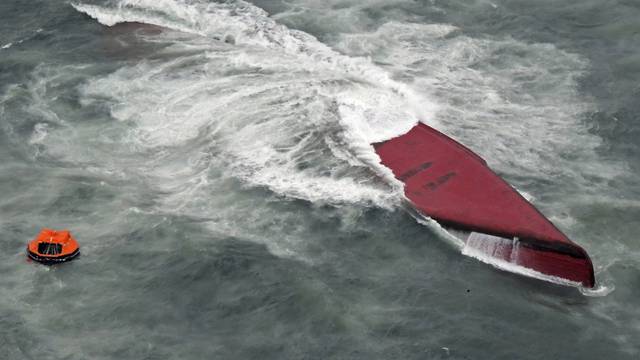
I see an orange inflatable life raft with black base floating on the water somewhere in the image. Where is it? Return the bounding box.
[27,229,80,265]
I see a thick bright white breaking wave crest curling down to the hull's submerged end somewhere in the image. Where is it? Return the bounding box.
[72,0,437,143]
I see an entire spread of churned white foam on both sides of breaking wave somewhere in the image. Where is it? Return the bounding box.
[15,0,600,292]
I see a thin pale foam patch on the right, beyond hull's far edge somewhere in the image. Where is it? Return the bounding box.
[336,22,624,188]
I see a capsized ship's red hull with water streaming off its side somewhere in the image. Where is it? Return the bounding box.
[373,123,595,288]
